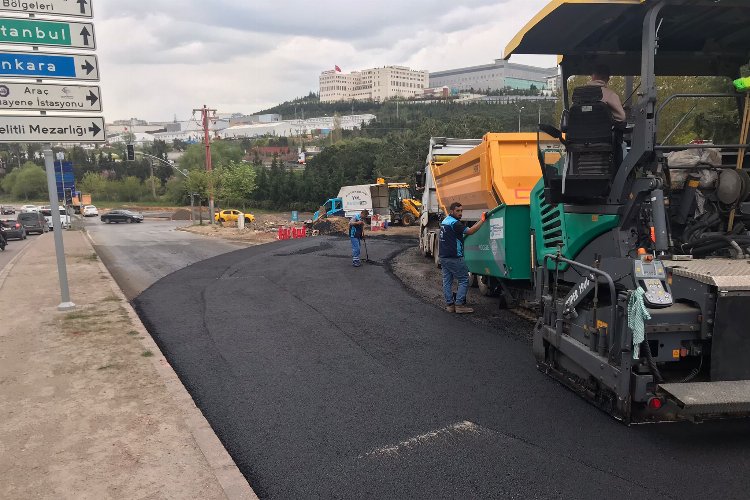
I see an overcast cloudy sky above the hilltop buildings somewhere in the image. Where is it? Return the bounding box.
[93,0,555,121]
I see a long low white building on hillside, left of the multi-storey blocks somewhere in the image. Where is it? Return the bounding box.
[218,114,375,139]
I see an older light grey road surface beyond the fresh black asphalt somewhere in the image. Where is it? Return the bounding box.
[84,219,247,299]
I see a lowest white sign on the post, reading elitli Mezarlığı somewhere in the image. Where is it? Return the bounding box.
[0,115,106,143]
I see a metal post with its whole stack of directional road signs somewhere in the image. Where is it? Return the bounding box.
[0,0,106,311]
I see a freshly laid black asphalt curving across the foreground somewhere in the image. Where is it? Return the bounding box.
[135,237,750,499]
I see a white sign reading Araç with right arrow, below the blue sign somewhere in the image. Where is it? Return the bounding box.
[0,81,102,112]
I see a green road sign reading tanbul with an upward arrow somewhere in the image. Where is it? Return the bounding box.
[0,17,96,49]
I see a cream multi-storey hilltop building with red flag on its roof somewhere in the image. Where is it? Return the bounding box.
[319,66,430,102]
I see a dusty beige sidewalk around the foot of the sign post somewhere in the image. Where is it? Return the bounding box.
[0,231,256,499]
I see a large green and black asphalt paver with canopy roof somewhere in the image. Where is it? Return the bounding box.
[502,0,750,423]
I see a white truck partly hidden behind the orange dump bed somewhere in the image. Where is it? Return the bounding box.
[417,137,482,265]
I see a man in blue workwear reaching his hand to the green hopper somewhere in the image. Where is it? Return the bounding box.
[440,202,485,314]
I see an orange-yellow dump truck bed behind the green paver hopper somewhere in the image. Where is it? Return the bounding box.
[433,133,560,221]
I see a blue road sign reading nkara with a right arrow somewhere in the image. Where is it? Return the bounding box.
[0,50,99,81]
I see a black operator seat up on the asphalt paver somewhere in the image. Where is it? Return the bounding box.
[546,85,622,204]
